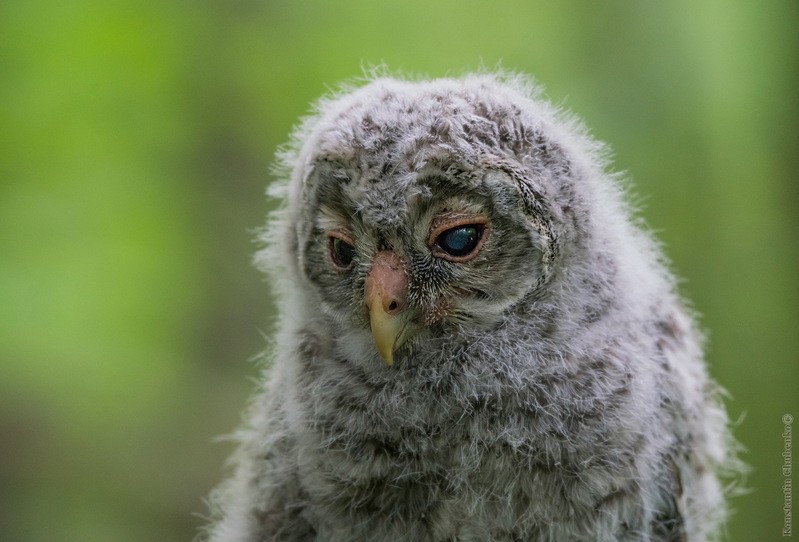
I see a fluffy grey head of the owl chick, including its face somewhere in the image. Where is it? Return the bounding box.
[266,75,648,366]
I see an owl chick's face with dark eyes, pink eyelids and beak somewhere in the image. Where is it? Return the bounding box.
[301,164,542,365]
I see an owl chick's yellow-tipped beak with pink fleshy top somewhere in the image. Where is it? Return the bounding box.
[364,250,408,366]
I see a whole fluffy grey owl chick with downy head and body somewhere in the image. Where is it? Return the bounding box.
[209,74,732,542]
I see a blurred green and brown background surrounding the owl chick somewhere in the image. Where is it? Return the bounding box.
[0,0,799,541]
